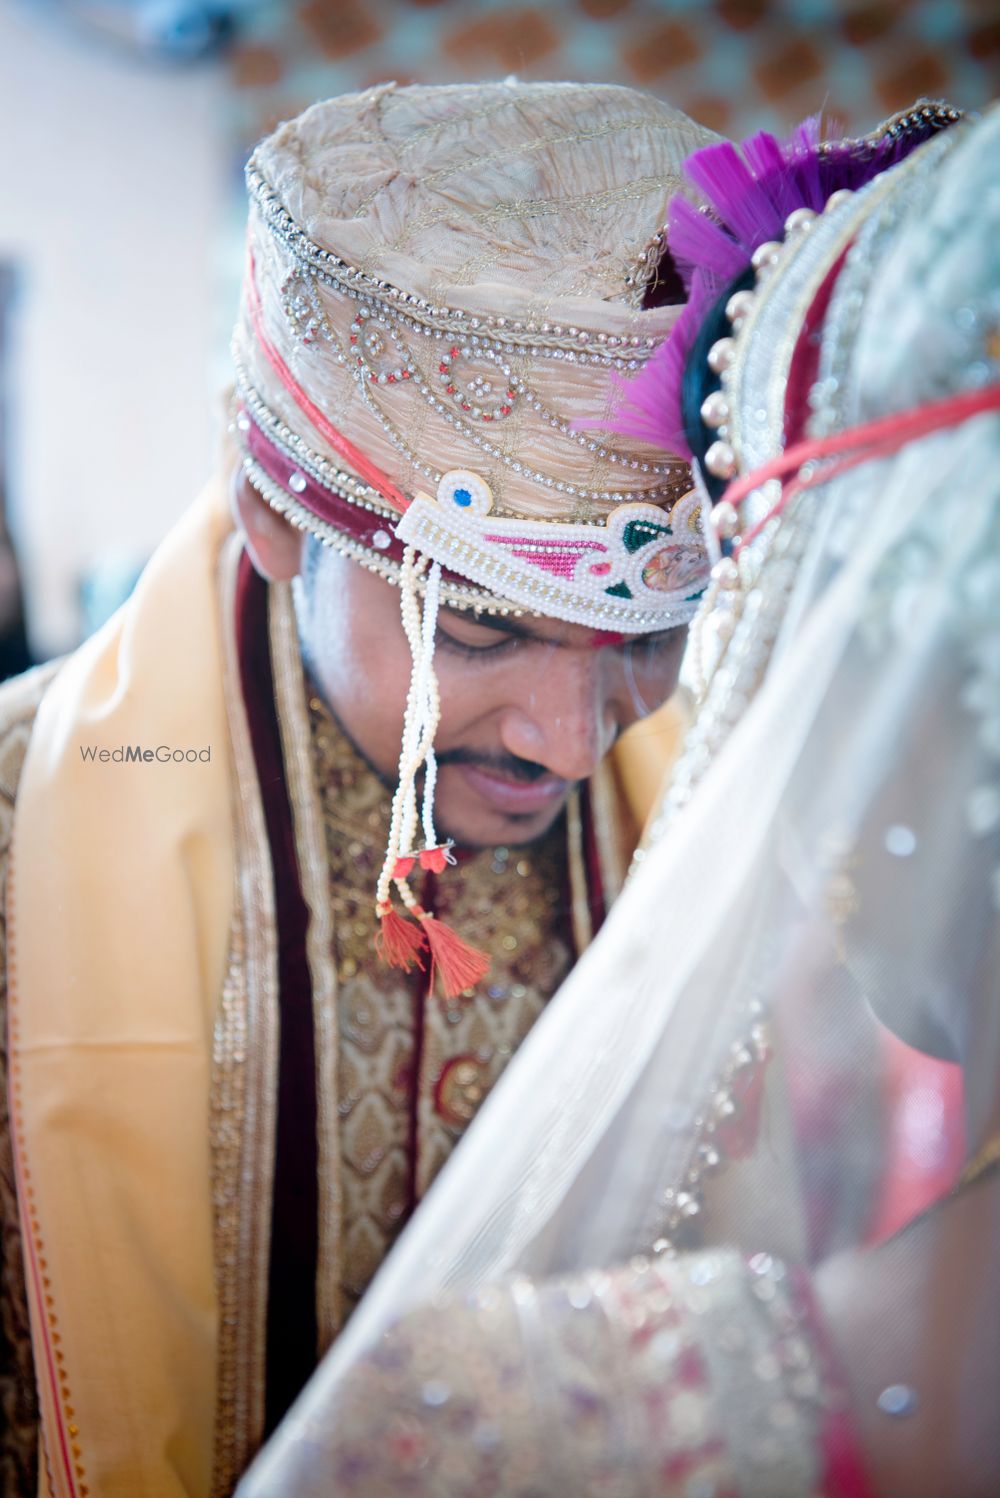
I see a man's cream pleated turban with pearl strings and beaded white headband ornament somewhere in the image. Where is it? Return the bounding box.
[234,82,711,632]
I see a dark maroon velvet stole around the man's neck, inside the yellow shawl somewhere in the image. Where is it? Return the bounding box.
[235,553,605,1438]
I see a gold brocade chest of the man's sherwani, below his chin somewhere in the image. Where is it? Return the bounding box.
[310,697,572,1312]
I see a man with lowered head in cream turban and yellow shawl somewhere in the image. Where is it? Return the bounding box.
[0,84,718,1495]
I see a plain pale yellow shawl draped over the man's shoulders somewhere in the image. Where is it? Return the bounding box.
[7,487,672,1498]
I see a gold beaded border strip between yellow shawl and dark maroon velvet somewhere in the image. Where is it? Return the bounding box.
[210,538,277,1498]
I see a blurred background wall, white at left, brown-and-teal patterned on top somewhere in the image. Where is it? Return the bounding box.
[0,0,1000,662]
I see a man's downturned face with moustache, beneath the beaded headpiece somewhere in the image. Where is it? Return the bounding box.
[296,544,686,846]
